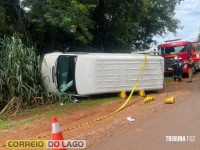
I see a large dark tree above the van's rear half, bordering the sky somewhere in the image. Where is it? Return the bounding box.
[87,0,180,51]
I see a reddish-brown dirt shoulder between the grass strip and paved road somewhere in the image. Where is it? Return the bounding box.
[0,72,200,149]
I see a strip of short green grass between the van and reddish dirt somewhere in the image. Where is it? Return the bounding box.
[0,97,119,130]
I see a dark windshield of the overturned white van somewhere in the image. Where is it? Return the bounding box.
[57,55,76,93]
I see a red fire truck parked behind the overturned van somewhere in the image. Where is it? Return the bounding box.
[158,39,200,74]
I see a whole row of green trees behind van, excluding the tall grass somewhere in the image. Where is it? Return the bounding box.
[0,0,181,53]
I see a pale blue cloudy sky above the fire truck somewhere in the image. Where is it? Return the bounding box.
[154,0,200,44]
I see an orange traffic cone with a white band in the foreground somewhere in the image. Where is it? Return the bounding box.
[52,116,66,150]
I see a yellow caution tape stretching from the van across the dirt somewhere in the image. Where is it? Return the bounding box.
[0,54,147,147]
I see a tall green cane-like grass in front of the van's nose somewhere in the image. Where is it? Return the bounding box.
[0,36,46,112]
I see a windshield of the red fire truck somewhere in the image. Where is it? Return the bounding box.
[159,46,187,54]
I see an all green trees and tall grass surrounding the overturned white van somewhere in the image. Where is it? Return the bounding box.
[0,0,181,110]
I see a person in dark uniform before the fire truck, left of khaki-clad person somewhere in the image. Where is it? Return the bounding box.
[171,56,183,82]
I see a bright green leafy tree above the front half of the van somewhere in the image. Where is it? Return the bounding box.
[23,0,94,53]
